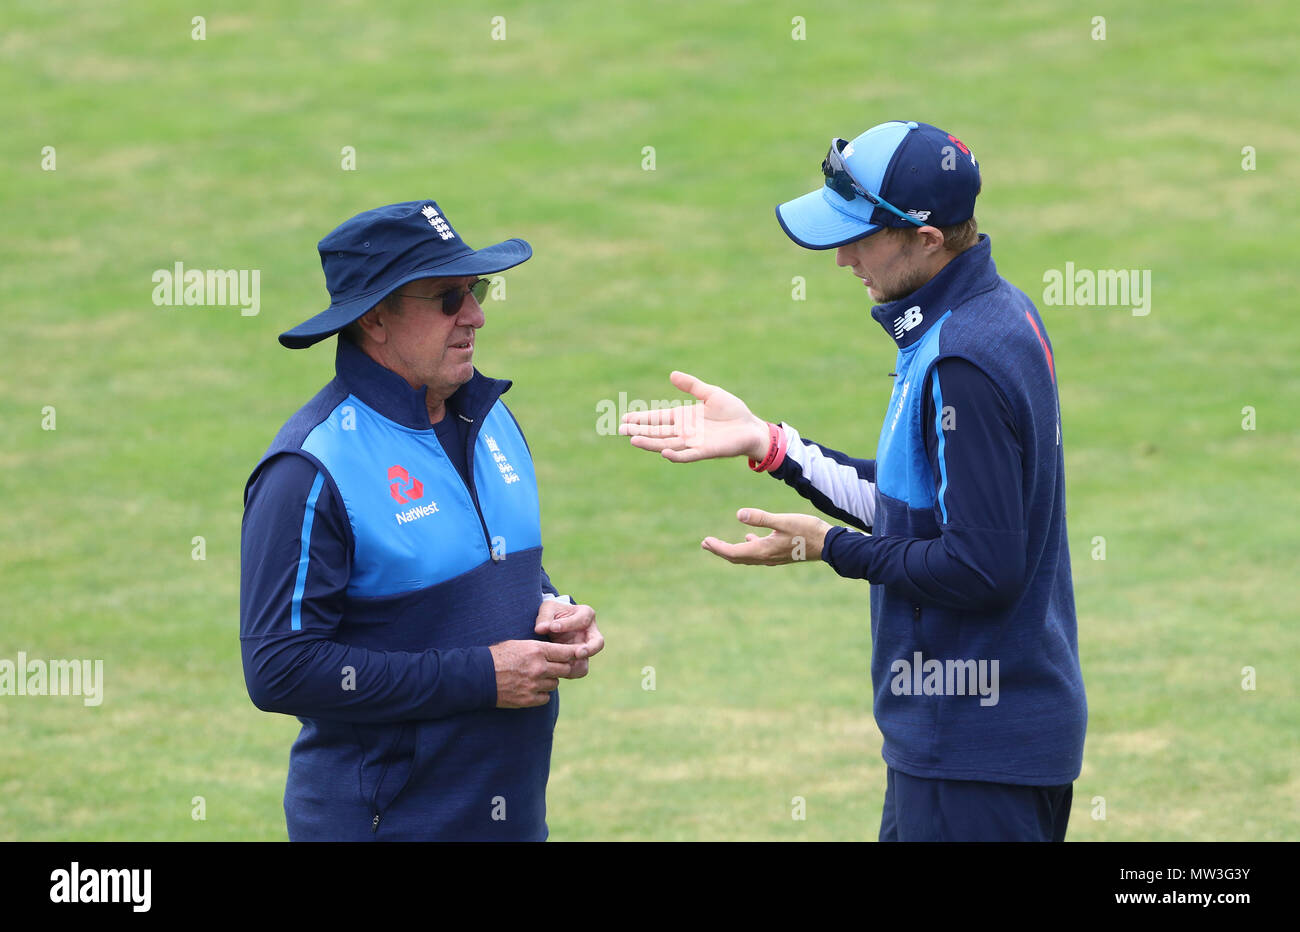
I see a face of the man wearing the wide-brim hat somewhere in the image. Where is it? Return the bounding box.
[384,276,486,398]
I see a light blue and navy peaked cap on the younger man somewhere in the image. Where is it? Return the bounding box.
[776,121,980,250]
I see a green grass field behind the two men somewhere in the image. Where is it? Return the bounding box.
[0,0,1300,841]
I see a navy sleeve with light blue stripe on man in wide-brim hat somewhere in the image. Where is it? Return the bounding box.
[239,454,497,723]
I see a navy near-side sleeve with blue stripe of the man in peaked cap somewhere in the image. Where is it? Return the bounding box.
[822,357,1026,608]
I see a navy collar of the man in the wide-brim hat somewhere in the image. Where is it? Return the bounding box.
[334,337,511,430]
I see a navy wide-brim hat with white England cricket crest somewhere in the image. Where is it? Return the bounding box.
[280,200,533,350]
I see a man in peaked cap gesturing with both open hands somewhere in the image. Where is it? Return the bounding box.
[621,122,1087,841]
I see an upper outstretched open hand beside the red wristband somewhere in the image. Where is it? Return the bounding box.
[619,372,770,463]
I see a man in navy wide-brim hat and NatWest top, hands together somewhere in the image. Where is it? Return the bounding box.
[241,200,603,841]
